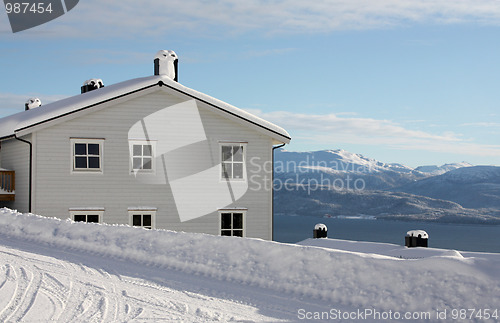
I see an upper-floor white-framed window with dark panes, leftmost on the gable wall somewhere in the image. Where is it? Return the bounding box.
[70,138,104,172]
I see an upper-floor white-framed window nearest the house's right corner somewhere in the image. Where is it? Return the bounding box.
[220,142,246,180]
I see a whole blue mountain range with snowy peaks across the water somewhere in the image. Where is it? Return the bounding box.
[275,150,500,224]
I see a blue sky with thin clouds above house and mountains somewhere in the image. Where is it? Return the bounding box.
[0,0,500,166]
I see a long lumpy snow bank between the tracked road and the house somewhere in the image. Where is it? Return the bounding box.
[0,208,500,311]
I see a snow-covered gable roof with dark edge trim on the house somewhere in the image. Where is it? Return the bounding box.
[0,75,291,143]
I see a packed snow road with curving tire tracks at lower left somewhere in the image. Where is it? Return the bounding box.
[0,236,325,322]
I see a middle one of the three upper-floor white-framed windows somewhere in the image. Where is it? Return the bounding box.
[129,140,156,173]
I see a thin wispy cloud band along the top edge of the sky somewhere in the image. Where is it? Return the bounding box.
[6,0,500,37]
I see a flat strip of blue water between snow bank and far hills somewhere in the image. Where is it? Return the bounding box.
[274,216,500,253]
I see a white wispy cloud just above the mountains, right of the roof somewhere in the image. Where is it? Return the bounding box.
[248,110,500,156]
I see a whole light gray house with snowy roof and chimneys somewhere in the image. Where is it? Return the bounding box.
[0,51,290,239]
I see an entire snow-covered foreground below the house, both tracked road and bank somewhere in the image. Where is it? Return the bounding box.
[0,209,500,322]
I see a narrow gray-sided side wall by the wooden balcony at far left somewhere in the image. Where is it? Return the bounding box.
[1,135,31,213]
